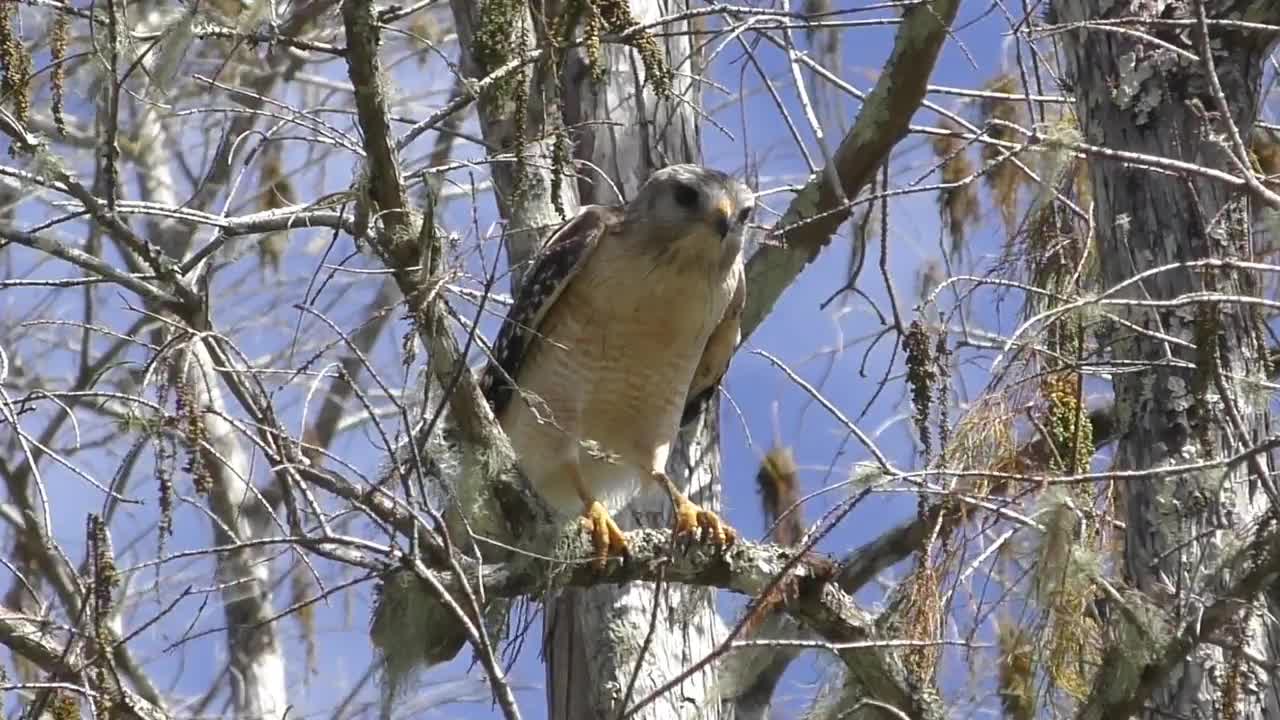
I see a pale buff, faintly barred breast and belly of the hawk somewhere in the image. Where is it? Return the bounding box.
[504,237,732,486]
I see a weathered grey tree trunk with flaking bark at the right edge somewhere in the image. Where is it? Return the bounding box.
[1055,0,1280,719]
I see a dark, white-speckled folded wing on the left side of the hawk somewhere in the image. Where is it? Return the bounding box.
[480,205,622,415]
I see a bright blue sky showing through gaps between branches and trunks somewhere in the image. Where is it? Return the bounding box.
[0,3,1070,719]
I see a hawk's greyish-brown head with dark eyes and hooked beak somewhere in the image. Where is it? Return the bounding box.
[626,165,755,265]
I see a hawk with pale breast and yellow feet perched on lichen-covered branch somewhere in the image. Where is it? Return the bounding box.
[480,164,754,569]
